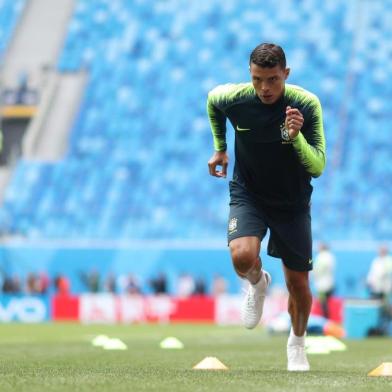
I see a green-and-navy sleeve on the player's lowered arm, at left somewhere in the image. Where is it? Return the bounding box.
[207,89,227,151]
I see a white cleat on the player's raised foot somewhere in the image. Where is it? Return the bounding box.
[241,271,271,329]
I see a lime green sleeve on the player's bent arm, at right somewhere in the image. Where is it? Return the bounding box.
[293,98,326,177]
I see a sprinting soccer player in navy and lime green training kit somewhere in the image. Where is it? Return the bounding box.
[207,43,326,371]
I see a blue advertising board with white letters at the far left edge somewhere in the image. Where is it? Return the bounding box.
[0,295,49,323]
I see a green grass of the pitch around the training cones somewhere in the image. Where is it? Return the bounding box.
[0,324,392,392]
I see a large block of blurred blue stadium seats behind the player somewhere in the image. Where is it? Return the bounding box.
[0,0,392,241]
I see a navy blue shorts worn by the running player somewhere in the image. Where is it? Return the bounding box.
[227,181,313,271]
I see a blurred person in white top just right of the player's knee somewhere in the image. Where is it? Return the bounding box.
[313,243,335,318]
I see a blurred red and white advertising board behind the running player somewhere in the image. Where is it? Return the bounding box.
[52,290,341,325]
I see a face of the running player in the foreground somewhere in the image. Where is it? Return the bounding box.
[249,63,290,105]
